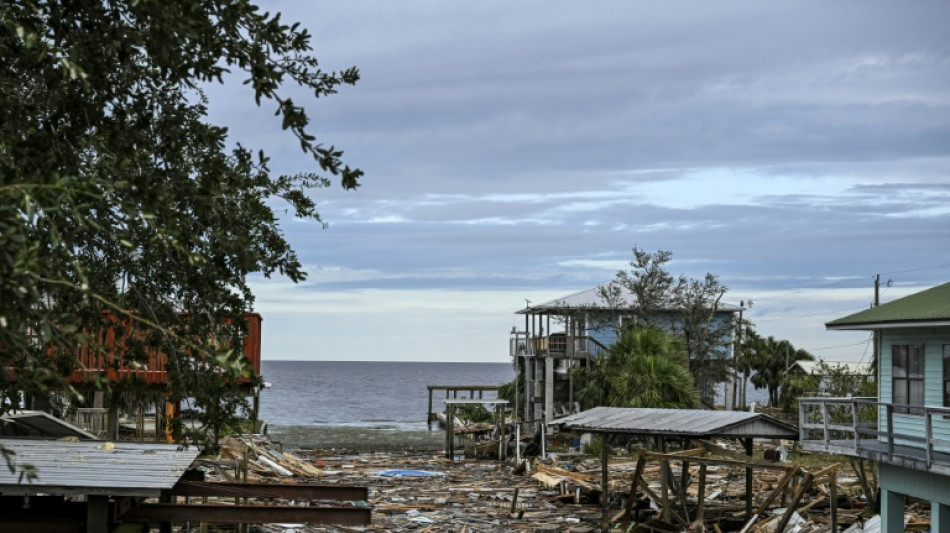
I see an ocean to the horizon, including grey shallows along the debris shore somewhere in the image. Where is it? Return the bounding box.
[260,360,765,452]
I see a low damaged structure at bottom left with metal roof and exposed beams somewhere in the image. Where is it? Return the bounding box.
[0,439,371,533]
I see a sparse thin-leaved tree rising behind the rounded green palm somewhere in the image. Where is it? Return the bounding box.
[601,247,735,402]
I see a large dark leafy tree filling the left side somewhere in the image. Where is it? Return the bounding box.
[0,0,362,456]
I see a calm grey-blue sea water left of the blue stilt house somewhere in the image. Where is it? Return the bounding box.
[261,361,514,430]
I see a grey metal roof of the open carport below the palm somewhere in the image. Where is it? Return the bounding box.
[555,407,798,440]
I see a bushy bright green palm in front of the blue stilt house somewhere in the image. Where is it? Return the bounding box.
[574,326,698,409]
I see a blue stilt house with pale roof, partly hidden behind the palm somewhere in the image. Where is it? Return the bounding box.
[509,286,741,423]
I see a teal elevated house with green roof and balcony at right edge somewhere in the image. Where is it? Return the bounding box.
[799,283,950,533]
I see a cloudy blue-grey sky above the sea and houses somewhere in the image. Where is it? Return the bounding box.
[208,0,950,362]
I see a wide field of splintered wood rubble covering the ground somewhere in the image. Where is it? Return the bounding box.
[193,437,926,533]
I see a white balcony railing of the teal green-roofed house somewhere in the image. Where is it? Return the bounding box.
[799,398,950,468]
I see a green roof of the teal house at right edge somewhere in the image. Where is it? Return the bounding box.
[825,283,950,329]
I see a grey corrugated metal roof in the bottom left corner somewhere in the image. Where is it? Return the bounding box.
[0,439,199,496]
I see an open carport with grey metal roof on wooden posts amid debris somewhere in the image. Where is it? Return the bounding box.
[556,407,798,531]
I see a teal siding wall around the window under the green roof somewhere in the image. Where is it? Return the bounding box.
[880,327,950,451]
